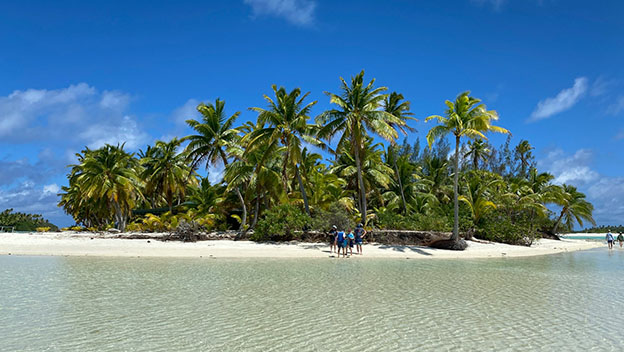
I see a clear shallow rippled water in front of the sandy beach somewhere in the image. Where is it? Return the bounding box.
[0,249,624,351]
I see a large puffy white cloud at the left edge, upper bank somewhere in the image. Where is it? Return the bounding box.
[0,83,148,149]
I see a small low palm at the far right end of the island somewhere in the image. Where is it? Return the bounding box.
[553,184,596,234]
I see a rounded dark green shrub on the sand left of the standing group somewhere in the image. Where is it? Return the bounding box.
[250,204,311,241]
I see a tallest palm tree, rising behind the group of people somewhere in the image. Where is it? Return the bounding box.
[316,70,407,223]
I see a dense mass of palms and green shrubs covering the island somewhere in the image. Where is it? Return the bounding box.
[59,72,594,244]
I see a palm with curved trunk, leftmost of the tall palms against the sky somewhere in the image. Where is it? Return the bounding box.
[182,98,247,230]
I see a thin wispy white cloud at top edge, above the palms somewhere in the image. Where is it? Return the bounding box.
[244,0,316,26]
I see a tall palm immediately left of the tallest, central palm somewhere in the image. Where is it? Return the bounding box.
[244,84,320,215]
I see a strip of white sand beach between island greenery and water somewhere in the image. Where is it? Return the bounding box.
[0,232,604,259]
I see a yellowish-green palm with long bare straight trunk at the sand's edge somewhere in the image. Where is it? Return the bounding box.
[425,91,509,241]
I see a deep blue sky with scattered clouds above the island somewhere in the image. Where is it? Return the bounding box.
[0,0,624,225]
